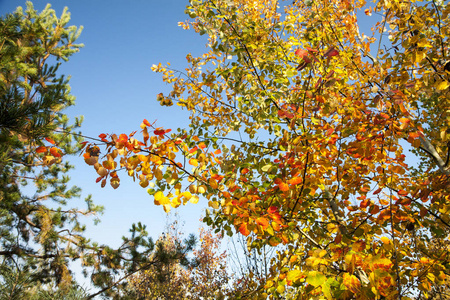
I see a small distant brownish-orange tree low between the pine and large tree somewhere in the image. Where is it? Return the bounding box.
[124,220,228,300]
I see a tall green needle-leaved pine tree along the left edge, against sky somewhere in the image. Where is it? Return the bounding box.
[0,2,101,285]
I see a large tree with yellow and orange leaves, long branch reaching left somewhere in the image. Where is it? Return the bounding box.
[84,0,450,299]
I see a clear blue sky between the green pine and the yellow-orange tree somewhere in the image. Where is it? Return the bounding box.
[0,0,206,246]
